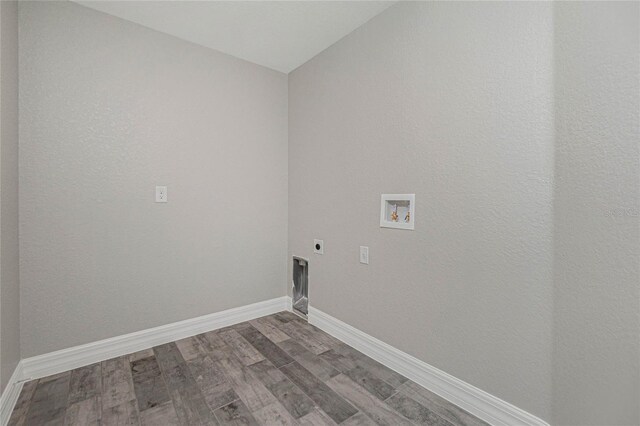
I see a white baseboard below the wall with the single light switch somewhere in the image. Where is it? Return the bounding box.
[18,296,290,380]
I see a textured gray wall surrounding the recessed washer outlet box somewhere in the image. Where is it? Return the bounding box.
[289,2,554,420]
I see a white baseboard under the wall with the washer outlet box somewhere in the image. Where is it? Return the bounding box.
[309,306,549,426]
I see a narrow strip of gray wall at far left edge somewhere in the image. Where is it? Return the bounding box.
[0,1,20,392]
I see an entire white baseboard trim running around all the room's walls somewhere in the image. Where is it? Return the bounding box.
[0,296,549,426]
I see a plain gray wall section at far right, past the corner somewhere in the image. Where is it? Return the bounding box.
[553,2,640,425]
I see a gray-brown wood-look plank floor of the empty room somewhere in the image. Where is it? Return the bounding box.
[9,312,486,426]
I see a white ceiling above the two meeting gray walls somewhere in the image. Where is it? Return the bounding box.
[76,0,395,73]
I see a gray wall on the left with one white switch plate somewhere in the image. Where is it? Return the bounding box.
[20,2,287,357]
